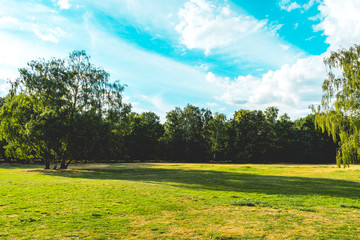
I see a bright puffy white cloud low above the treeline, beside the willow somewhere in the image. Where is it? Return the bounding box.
[206,55,326,117]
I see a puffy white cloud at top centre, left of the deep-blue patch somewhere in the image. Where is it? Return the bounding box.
[176,0,267,54]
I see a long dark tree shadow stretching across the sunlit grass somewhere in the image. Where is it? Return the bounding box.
[41,167,360,200]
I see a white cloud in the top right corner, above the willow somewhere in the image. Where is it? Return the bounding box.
[314,0,360,50]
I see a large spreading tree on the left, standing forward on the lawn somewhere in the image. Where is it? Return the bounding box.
[0,51,124,169]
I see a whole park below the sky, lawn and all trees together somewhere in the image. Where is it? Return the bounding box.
[0,14,360,239]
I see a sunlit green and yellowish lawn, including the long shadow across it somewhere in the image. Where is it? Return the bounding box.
[0,164,360,239]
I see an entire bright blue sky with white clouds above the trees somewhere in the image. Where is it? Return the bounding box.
[0,0,360,121]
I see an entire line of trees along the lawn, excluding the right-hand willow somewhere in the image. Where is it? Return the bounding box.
[0,51,338,168]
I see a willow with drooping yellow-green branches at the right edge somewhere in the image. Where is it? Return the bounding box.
[316,45,360,167]
